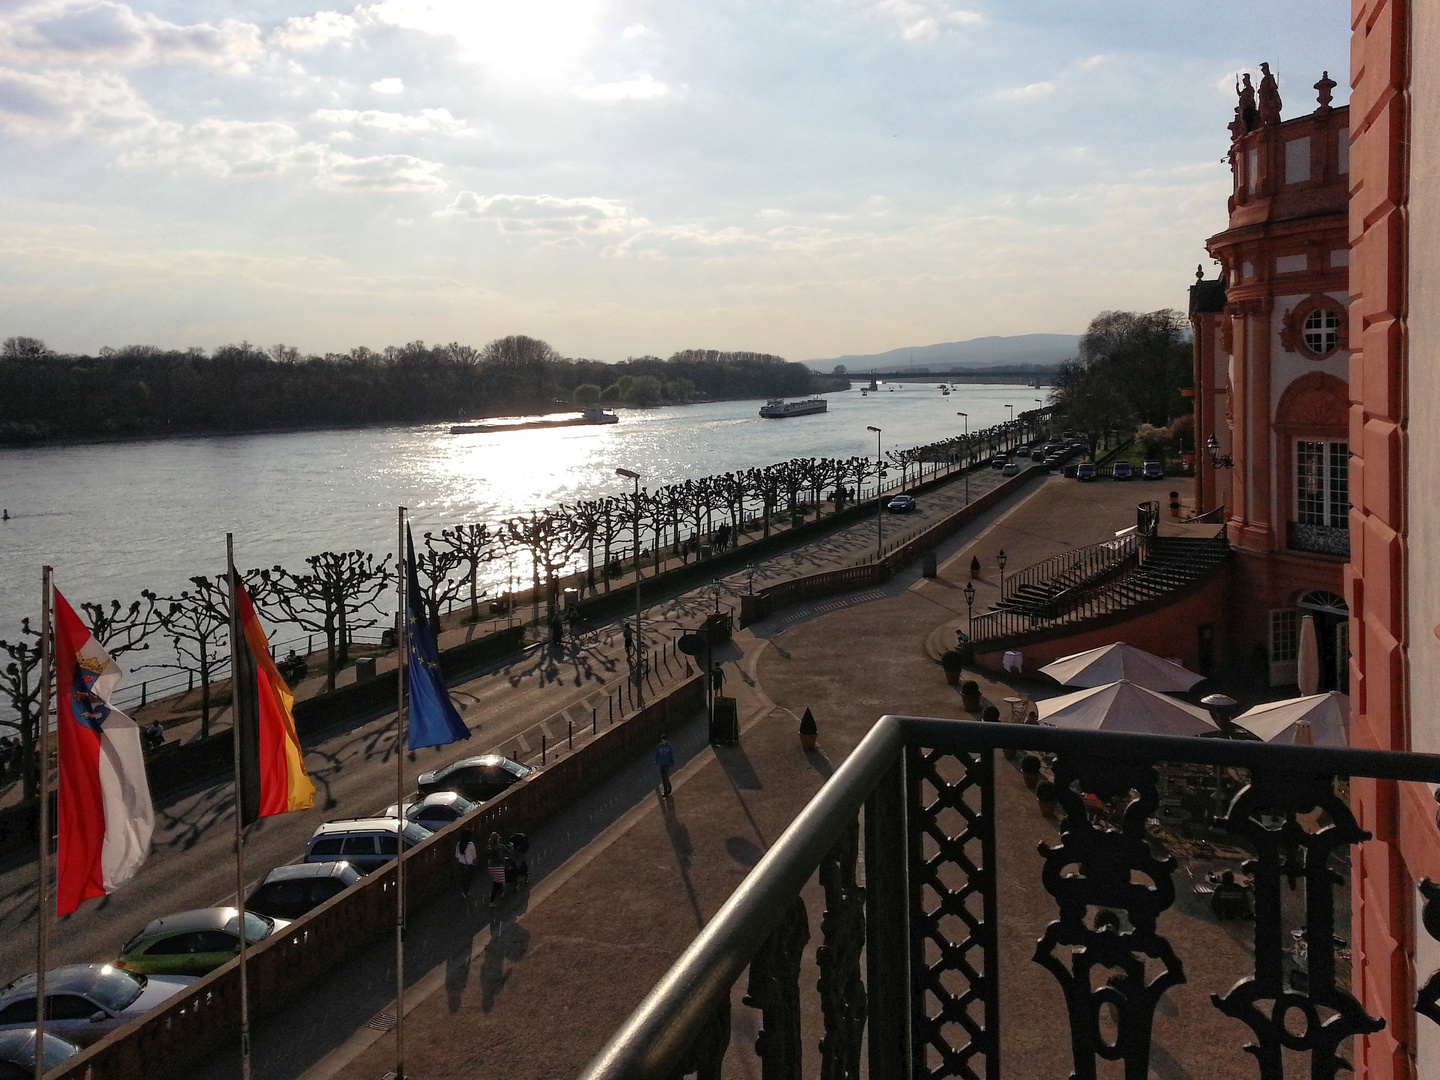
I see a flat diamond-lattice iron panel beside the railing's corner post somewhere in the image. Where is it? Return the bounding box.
[906,747,999,1080]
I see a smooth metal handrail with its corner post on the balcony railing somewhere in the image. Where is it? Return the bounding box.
[580,714,1440,1080]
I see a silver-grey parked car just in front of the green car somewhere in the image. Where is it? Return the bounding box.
[0,963,197,1047]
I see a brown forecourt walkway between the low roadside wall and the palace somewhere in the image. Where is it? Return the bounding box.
[180,478,1272,1080]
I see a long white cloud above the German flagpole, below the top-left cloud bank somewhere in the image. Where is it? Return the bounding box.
[118,120,324,179]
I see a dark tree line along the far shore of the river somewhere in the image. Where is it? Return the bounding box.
[0,336,850,444]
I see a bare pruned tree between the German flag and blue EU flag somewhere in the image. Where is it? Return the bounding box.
[275,550,392,691]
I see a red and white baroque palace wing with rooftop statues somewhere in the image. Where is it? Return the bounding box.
[1189,65,1351,690]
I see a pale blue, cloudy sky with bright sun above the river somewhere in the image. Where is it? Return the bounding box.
[0,0,1349,360]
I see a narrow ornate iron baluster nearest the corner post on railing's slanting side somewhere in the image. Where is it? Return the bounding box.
[815,821,867,1080]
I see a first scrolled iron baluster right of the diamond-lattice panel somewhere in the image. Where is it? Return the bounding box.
[1034,755,1185,1080]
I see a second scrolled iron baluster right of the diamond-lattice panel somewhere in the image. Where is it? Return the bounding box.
[1211,769,1385,1080]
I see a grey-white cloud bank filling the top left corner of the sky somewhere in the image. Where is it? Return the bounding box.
[0,0,264,72]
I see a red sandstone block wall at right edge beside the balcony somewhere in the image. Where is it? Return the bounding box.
[1346,0,1440,1080]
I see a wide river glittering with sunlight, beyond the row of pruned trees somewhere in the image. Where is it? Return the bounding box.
[0,383,1045,636]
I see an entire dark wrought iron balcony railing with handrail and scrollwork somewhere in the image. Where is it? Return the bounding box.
[583,716,1440,1080]
